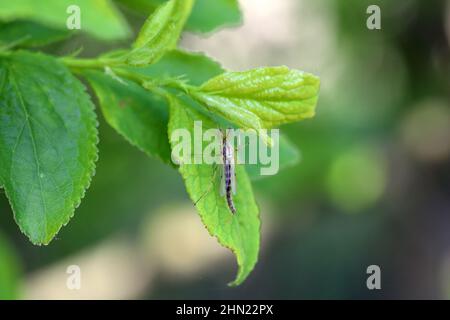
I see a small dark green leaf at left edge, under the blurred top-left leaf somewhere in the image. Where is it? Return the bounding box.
[0,20,70,47]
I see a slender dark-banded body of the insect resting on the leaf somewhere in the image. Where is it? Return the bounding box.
[221,133,236,214]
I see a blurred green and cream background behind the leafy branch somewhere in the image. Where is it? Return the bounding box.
[0,0,450,299]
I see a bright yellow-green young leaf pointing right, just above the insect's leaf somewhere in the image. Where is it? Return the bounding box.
[189,67,320,130]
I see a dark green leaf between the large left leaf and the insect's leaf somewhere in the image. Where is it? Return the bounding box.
[84,71,171,163]
